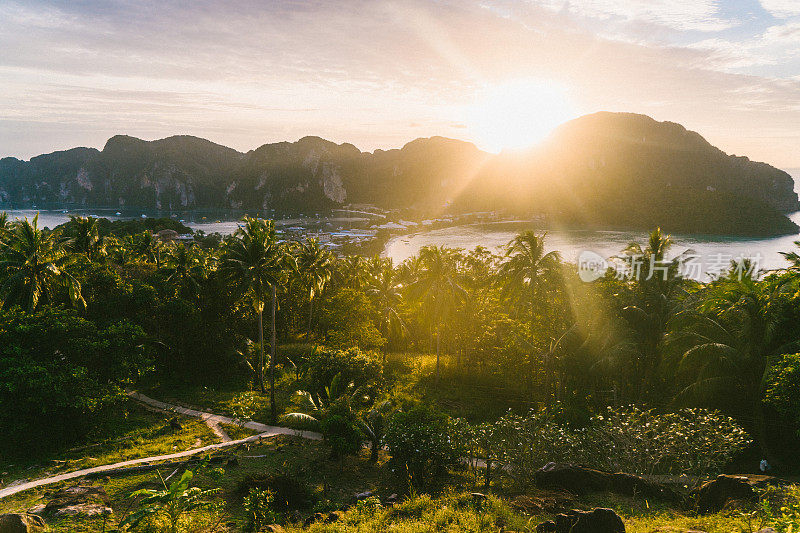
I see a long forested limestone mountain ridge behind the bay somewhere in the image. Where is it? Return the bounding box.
[0,113,800,234]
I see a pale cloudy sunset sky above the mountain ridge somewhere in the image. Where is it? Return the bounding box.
[0,0,800,169]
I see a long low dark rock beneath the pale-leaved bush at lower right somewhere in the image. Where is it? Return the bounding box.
[534,463,683,504]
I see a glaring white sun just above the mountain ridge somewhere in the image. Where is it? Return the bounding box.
[466,79,578,153]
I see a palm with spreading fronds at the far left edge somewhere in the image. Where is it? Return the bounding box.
[0,215,86,312]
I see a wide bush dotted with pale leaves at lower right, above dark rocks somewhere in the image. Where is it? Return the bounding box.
[481,406,750,487]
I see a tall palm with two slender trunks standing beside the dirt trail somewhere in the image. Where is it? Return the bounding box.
[220,217,293,420]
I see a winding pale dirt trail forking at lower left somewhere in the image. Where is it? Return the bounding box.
[0,391,322,498]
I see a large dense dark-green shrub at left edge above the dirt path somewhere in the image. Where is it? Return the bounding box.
[0,309,145,457]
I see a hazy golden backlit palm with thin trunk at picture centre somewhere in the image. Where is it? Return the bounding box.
[411,246,464,385]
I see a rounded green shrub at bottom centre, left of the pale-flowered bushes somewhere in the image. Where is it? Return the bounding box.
[385,406,464,484]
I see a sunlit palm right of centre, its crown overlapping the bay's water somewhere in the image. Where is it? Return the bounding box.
[499,231,561,335]
